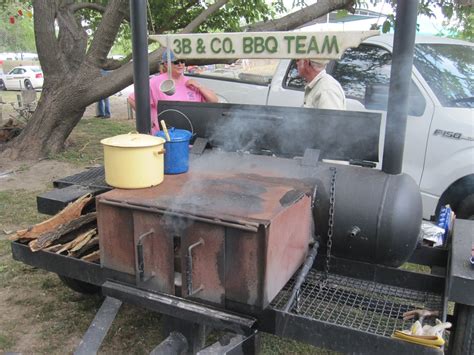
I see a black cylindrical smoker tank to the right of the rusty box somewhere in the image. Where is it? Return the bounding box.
[314,164,422,267]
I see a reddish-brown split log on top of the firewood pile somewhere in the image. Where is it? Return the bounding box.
[9,194,93,241]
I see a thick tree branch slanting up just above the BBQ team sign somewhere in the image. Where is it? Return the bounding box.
[245,0,354,32]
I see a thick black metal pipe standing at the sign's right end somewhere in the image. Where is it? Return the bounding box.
[382,0,418,174]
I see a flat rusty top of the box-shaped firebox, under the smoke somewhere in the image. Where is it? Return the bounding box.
[98,173,311,225]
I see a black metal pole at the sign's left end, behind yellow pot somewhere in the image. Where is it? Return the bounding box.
[130,0,151,133]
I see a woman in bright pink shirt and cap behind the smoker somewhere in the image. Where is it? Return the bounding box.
[128,51,218,135]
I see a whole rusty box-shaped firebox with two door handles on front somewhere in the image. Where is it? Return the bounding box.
[97,169,312,311]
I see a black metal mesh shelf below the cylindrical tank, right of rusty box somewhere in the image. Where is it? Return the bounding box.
[272,270,442,336]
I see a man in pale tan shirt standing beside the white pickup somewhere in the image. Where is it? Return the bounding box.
[296,59,346,110]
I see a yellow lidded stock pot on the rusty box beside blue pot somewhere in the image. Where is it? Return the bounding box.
[100,133,165,189]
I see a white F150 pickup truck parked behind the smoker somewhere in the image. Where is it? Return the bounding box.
[189,35,474,219]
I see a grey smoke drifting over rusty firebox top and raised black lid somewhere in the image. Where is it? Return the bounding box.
[158,105,380,239]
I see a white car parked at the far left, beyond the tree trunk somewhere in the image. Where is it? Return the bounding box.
[0,65,44,90]
